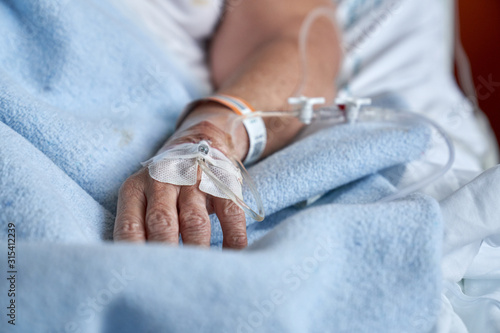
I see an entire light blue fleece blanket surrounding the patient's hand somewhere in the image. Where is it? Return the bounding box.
[0,0,442,333]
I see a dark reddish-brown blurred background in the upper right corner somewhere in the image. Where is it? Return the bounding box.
[458,0,500,145]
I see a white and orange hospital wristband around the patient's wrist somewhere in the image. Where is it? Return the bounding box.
[178,94,267,165]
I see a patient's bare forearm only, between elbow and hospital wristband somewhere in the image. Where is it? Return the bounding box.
[179,1,341,158]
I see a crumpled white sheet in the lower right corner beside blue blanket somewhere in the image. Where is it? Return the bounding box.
[435,166,500,333]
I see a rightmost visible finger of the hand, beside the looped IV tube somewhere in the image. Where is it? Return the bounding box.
[213,198,248,249]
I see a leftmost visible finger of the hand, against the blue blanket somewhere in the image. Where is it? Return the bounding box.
[113,177,146,242]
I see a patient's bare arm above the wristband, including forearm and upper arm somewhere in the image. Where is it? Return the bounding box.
[187,0,341,159]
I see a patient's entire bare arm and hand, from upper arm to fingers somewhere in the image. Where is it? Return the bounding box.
[114,0,340,248]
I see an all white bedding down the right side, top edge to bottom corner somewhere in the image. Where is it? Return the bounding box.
[339,0,500,333]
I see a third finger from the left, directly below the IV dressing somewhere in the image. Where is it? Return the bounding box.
[177,185,210,246]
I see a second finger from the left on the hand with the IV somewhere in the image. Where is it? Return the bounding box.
[146,178,179,244]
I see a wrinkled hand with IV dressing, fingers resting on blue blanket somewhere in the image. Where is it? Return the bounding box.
[114,109,252,249]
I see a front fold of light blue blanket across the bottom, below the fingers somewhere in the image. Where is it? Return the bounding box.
[0,189,441,333]
